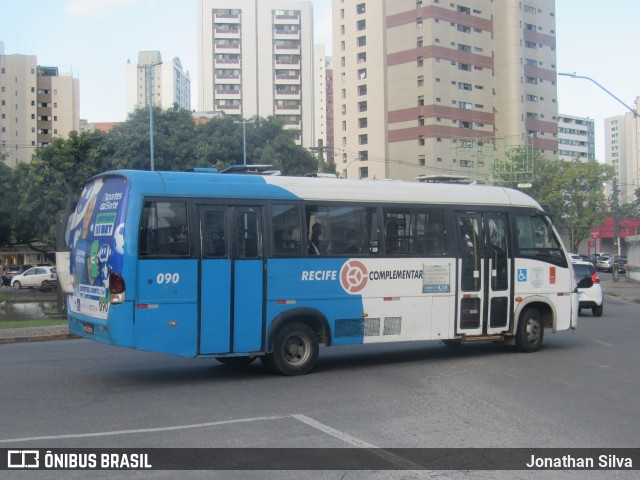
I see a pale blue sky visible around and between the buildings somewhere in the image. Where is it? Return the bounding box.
[0,0,640,161]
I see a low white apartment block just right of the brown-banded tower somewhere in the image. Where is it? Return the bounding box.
[558,115,596,162]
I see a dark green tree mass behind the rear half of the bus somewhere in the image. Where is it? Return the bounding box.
[0,107,318,247]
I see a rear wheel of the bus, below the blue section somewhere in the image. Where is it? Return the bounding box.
[261,323,319,375]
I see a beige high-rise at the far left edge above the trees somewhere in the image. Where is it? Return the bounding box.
[0,55,80,167]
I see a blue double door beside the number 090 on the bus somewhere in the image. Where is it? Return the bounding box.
[199,205,264,354]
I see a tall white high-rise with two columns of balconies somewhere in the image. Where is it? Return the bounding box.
[198,0,315,147]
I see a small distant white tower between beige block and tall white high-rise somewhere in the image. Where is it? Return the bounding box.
[125,50,191,113]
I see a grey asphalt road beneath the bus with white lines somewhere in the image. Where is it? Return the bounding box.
[0,297,640,479]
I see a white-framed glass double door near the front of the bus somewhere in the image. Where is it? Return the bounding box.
[456,213,511,335]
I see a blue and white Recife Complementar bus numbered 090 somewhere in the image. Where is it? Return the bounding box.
[58,171,578,375]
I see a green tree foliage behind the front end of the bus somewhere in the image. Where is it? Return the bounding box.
[496,149,614,252]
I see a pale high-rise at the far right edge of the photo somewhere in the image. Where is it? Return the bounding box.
[604,97,640,205]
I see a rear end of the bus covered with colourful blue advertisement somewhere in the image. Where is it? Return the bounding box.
[65,176,129,318]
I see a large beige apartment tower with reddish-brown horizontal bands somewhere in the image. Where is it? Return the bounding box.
[333,0,558,181]
